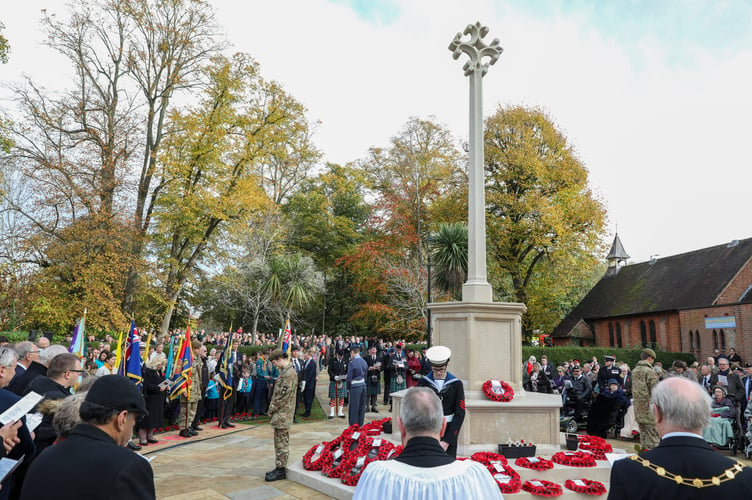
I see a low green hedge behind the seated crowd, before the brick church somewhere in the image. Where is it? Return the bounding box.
[522,346,697,369]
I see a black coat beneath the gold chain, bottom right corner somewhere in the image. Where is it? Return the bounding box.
[608,436,752,500]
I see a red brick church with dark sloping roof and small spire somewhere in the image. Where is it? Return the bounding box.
[551,234,752,361]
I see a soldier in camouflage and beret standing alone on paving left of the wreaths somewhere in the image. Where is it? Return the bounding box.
[266,349,298,481]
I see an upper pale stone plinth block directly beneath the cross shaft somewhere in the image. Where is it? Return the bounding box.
[428,302,524,392]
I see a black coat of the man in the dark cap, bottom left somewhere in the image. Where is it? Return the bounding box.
[19,424,156,500]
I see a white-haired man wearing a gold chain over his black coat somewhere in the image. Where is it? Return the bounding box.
[608,377,752,500]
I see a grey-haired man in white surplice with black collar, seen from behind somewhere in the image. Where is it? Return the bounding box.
[353,387,502,500]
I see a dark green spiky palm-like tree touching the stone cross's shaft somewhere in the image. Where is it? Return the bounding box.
[431,222,467,299]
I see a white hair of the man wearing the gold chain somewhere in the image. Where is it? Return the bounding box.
[651,377,711,432]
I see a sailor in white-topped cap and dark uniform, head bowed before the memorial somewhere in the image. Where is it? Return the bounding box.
[418,345,465,457]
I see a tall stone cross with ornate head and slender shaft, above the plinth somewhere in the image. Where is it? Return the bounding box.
[449,22,504,302]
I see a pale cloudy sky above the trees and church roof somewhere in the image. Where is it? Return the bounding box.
[0,0,752,262]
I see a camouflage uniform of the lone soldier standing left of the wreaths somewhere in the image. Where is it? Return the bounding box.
[269,363,298,468]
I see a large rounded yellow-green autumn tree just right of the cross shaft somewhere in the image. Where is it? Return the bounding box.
[485,106,606,331]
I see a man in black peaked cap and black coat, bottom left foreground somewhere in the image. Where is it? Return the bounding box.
[21,375,156,500]
